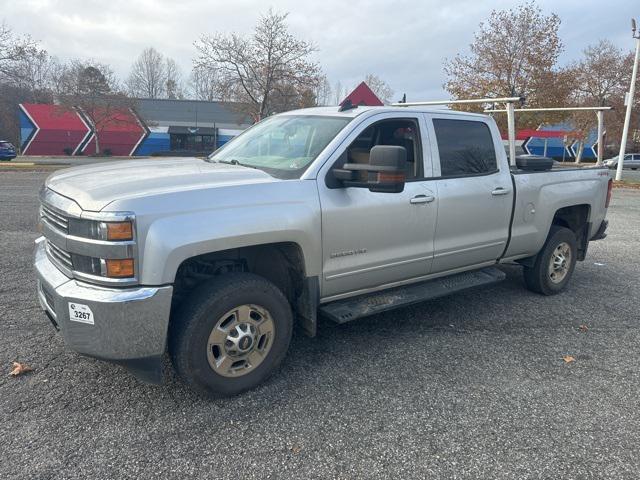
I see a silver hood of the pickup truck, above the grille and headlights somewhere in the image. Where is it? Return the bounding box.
[46,158,279,211]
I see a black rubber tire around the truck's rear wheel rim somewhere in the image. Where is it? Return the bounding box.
[524,225,578,295]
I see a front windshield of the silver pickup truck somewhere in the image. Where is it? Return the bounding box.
[209,115,352,179]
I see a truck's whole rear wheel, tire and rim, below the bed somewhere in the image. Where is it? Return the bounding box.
[524,225,578,295]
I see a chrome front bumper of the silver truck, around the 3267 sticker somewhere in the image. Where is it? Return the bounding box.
[35,237,173,383]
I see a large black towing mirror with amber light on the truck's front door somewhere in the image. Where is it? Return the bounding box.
[333,145,407,193]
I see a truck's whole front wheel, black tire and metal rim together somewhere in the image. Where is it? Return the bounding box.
[169,273,293,396]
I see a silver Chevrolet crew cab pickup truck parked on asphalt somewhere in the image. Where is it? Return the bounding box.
[35,107,611,396]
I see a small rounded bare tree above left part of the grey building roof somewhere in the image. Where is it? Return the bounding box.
[127,47,167,98]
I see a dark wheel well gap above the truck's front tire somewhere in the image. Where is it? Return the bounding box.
[172,242,305,309]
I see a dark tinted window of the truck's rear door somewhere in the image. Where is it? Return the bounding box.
[433,118,498,177]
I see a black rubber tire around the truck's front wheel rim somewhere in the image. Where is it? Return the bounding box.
[169,273,293,397]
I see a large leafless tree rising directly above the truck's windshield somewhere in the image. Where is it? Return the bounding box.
[195,10,320,121]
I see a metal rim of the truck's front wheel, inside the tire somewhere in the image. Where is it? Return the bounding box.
[207,305,275,377]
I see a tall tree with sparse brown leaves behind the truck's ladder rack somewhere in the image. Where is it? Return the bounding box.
[444,3,567,126]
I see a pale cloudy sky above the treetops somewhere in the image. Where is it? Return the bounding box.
[0,0,640,100]
